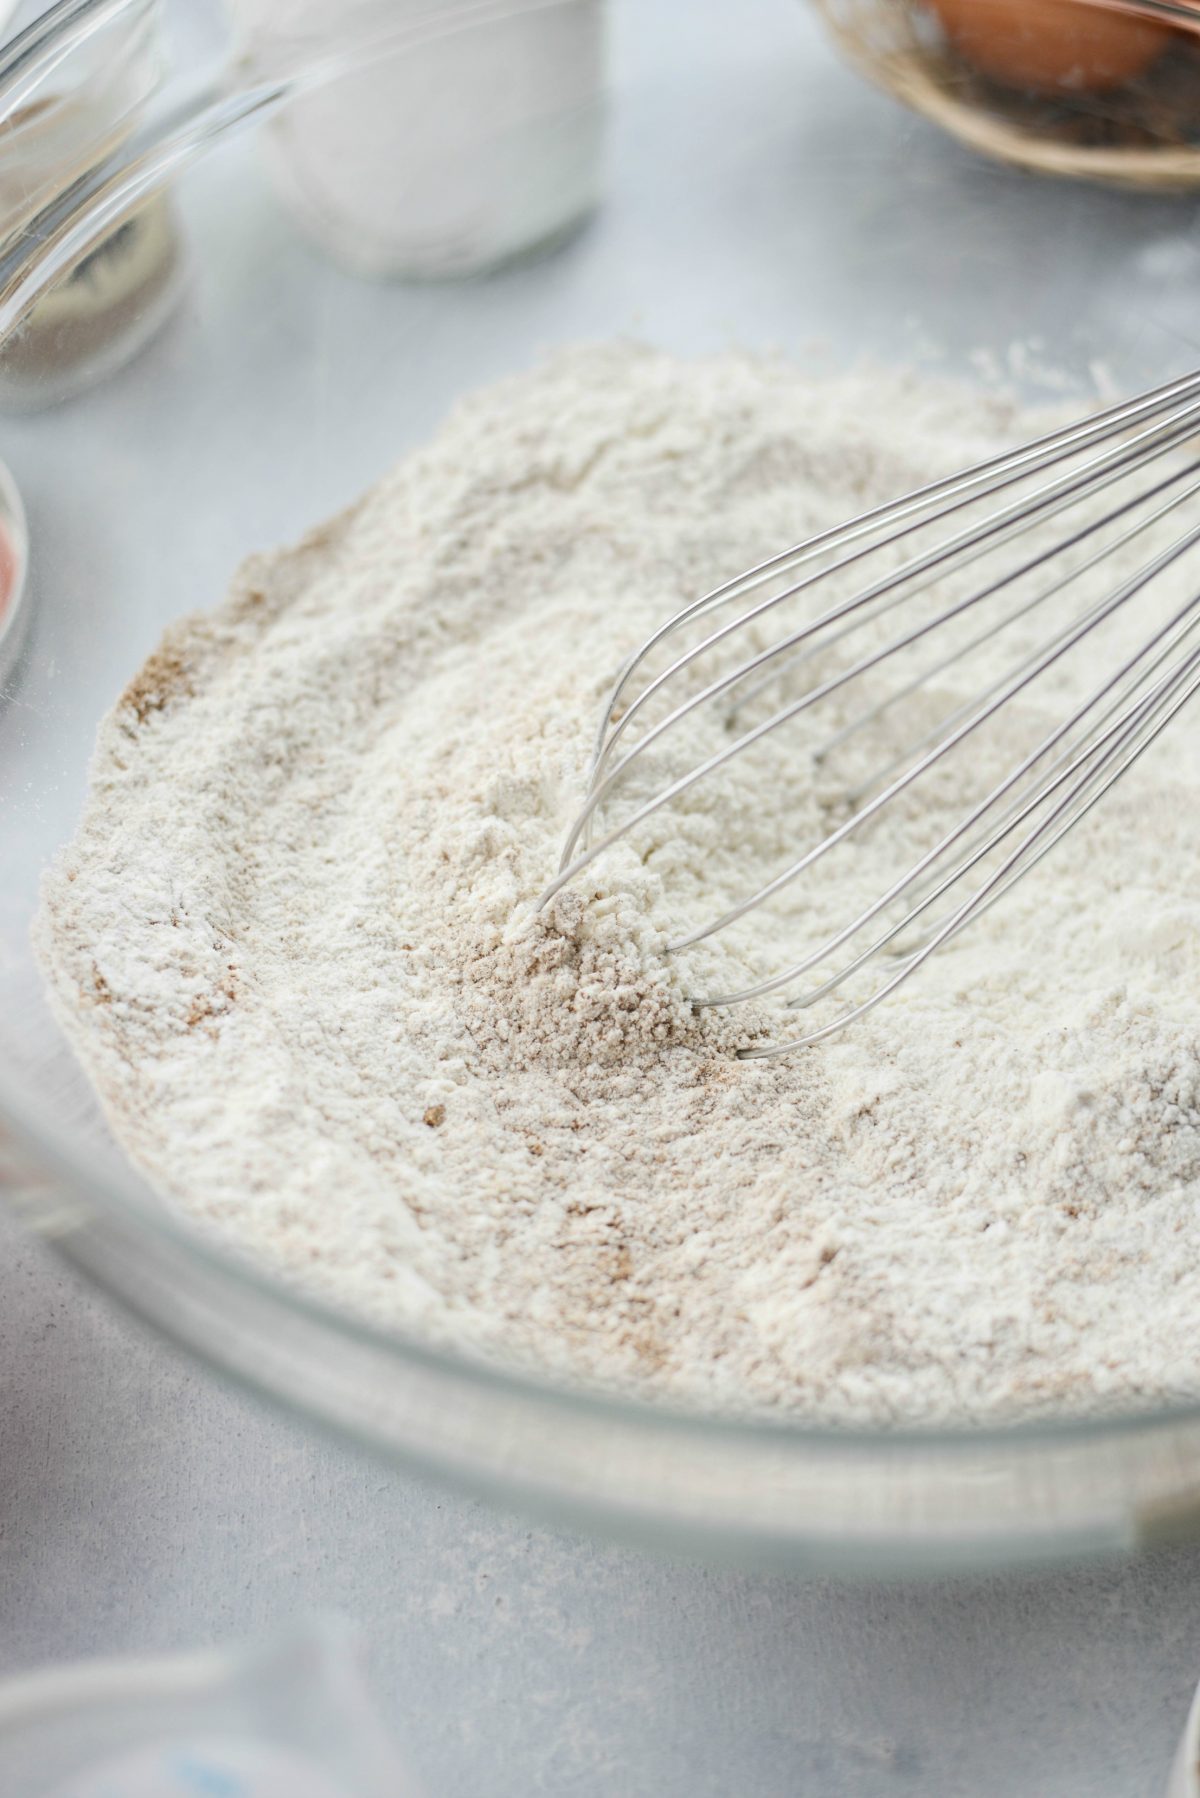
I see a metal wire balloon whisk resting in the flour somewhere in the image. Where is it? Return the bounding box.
[540,372,1200,1055]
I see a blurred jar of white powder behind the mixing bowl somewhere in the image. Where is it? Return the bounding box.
[228,0,604,279]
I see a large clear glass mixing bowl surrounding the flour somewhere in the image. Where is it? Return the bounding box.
[0,0,1200,1571]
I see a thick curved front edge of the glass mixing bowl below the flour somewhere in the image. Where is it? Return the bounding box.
[11,1050,1200,1573]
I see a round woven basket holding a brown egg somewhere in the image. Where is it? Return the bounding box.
[817,0,1200,192]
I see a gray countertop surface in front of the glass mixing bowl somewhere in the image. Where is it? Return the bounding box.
[0,1224,1200,1798]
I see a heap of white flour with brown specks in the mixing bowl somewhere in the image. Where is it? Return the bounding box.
[36,347,1200,1420]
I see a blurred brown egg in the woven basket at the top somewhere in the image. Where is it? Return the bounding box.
[927,0,1175,93]
